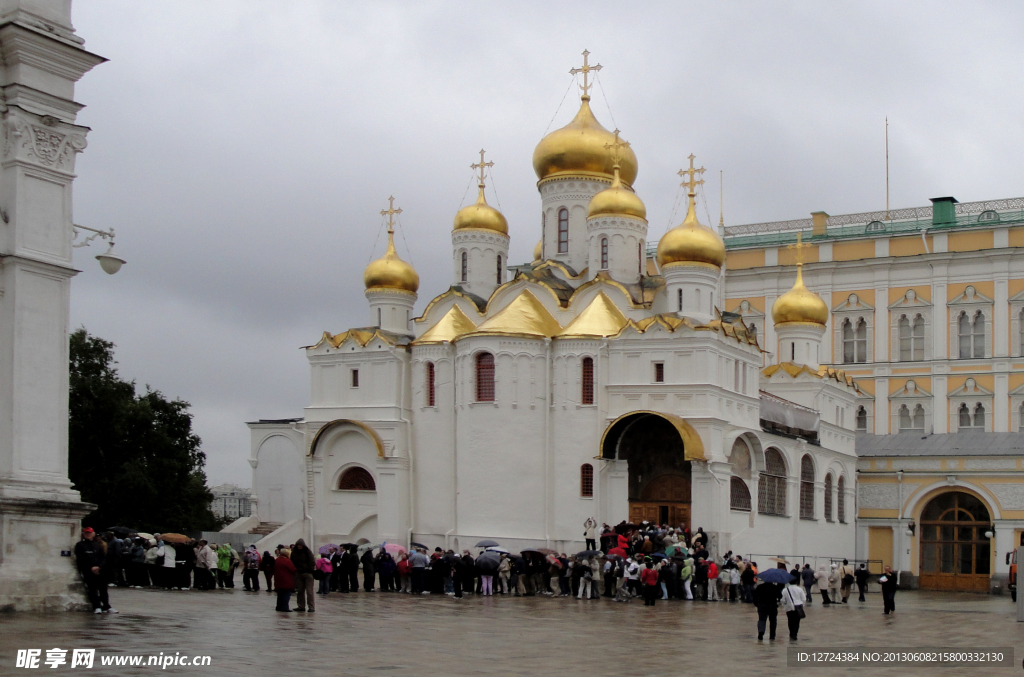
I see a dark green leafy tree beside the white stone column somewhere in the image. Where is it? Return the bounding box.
[69,329,219,533]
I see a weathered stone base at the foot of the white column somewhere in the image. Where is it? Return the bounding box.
[0,498,96,611]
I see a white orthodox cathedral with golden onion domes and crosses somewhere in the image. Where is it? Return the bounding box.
[243,52,859,557]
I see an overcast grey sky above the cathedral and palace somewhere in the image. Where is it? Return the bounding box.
[72,0,1024,486]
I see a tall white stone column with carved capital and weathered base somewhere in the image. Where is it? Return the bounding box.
[0,0,105,610]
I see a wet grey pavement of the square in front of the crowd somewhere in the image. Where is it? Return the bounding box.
[0,588,1024,677]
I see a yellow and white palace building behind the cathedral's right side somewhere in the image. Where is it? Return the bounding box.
[724,198,1024,590]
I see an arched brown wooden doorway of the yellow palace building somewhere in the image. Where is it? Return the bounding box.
[920,492,992,592]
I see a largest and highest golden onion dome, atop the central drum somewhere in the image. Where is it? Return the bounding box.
[534,94,637,185]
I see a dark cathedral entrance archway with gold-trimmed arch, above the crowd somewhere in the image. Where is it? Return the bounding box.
[601,412,703,526]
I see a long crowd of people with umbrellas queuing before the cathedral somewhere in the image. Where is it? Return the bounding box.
[76,519,896,640]
